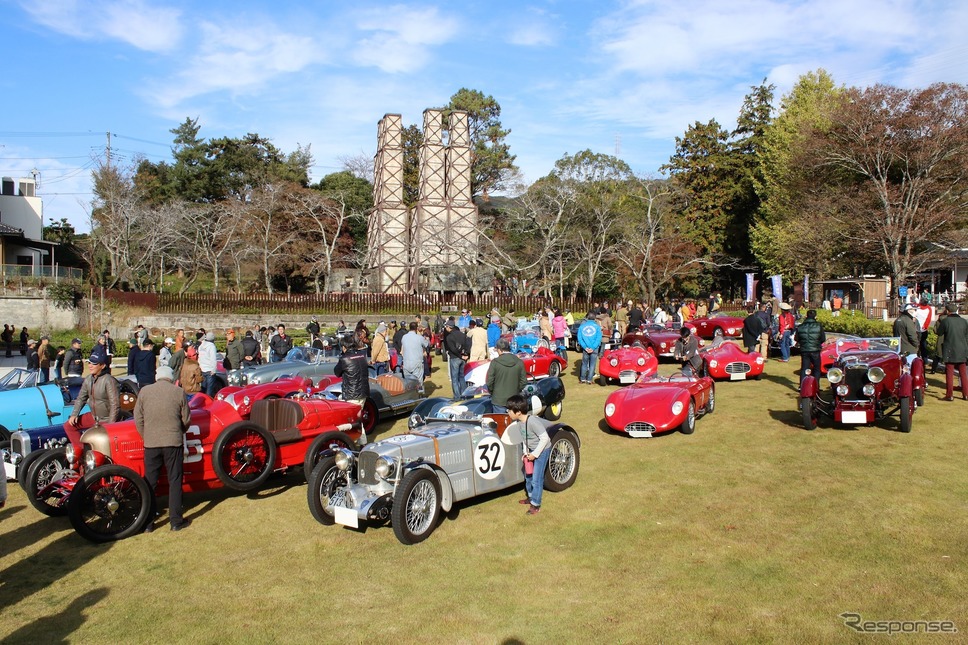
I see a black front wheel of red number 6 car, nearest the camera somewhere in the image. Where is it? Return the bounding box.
[67,465,154,542]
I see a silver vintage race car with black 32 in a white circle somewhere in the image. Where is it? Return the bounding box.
[307,410,581,544]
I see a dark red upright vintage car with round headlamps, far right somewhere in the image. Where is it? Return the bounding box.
[800,337,924,432]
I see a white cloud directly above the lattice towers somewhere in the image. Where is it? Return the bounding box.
[351,5,460,74]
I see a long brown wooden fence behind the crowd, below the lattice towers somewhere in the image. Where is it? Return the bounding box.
[106,289,588,316]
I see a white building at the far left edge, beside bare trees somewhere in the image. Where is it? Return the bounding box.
[0,177,57,276]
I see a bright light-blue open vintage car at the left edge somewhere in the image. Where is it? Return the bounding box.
[0,378,87,441]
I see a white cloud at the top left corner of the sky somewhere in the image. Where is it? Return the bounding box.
[20,0,182,52]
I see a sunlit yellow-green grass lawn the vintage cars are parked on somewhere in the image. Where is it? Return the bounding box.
[0,353,968,643]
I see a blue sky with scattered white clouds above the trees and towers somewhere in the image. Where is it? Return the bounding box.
[0,0,968,231]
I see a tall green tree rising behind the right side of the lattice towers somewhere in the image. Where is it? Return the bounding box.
[443,88,518,201]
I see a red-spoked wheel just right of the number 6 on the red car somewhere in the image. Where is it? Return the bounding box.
[212,421,277,493]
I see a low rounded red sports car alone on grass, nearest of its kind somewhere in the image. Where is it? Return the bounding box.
[605,374,716,438]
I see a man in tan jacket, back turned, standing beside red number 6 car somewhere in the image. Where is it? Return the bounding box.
[134,366,192,533]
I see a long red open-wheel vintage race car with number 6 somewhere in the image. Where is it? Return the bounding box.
[31,394,361,542]
